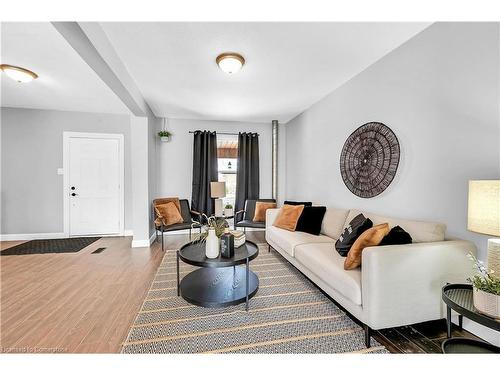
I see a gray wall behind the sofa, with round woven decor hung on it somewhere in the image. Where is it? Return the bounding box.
[285,23,500,258]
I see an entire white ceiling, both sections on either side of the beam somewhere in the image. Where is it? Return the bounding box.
[1,22,429,122]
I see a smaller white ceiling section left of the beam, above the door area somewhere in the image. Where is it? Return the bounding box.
[0,22,130,113]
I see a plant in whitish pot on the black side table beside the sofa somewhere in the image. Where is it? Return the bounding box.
[468,253,500,319]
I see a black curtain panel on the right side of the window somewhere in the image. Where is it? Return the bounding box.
[235,133,259,211]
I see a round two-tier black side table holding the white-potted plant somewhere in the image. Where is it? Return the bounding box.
[441,284,500,353]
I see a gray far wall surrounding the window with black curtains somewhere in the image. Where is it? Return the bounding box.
[156,119,272,203]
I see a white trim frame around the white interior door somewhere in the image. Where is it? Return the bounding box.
[63,132,125,237]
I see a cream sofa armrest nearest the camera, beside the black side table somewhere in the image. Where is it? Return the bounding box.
[361,240,477,329]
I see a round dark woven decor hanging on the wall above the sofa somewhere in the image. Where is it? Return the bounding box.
[340,122,400,198]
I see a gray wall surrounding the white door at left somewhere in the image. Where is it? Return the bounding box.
[1,108,132,234]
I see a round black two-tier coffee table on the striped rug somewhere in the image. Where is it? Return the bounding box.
[177,241,259,310]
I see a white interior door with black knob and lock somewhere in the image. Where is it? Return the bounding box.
[66,137,123,236]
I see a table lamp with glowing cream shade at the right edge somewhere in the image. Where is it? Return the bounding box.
[467,180,500,275]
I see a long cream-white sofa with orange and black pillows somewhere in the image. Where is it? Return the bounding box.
[266,208,476,346]
